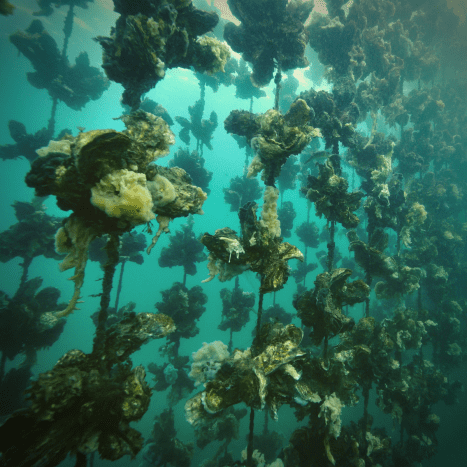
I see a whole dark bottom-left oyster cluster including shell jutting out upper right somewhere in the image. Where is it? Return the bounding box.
[0,313,174,465]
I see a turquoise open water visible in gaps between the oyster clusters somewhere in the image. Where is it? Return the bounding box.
[0,0,467,466]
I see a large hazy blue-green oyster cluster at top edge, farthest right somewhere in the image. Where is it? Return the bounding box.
[308,1,443,121]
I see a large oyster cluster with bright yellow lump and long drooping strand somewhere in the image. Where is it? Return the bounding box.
[26,111,206,315]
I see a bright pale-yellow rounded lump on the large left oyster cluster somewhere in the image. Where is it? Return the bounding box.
[91,169,155,225]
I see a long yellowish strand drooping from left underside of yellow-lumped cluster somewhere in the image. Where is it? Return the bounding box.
[55,217,96,318]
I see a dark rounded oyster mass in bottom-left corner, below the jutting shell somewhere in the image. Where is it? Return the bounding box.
[0,350,151,463]
